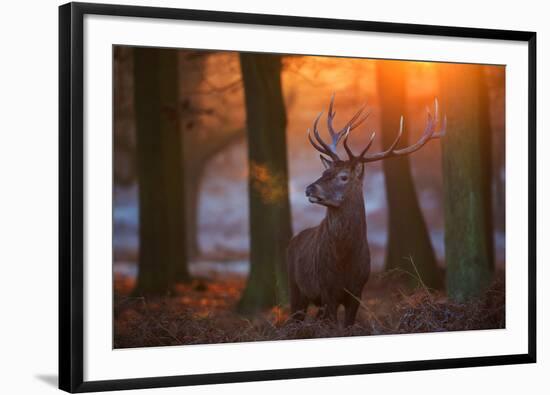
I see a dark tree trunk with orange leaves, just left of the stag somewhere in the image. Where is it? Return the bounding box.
[238,53,292,313]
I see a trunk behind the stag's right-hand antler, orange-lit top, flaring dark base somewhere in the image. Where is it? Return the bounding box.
[377,62,443,288]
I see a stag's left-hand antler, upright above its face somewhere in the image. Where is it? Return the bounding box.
[307,94,369,161]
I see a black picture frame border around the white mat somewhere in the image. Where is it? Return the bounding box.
[59,3,536,392]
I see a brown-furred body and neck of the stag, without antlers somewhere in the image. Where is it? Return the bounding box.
[287,162,370,325]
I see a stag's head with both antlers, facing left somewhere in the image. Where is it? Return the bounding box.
[306,95,447,208]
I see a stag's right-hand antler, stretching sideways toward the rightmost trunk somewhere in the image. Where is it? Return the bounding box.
[350,98,447,163]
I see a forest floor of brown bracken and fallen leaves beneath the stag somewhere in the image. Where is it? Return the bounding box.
[114,273,505,348]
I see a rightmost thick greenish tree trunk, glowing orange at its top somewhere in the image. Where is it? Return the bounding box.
[440,64,493,301]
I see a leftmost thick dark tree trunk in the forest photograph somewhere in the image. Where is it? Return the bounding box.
[134,48,189,295]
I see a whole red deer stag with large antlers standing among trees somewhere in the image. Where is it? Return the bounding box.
[287,96,446,326]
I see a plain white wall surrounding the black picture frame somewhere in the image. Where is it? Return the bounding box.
[0,0,550,395]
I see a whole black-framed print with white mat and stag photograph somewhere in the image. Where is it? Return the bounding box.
[59,3,536,392]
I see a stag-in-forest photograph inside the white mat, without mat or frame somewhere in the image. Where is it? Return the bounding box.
[113,44,508,349]
